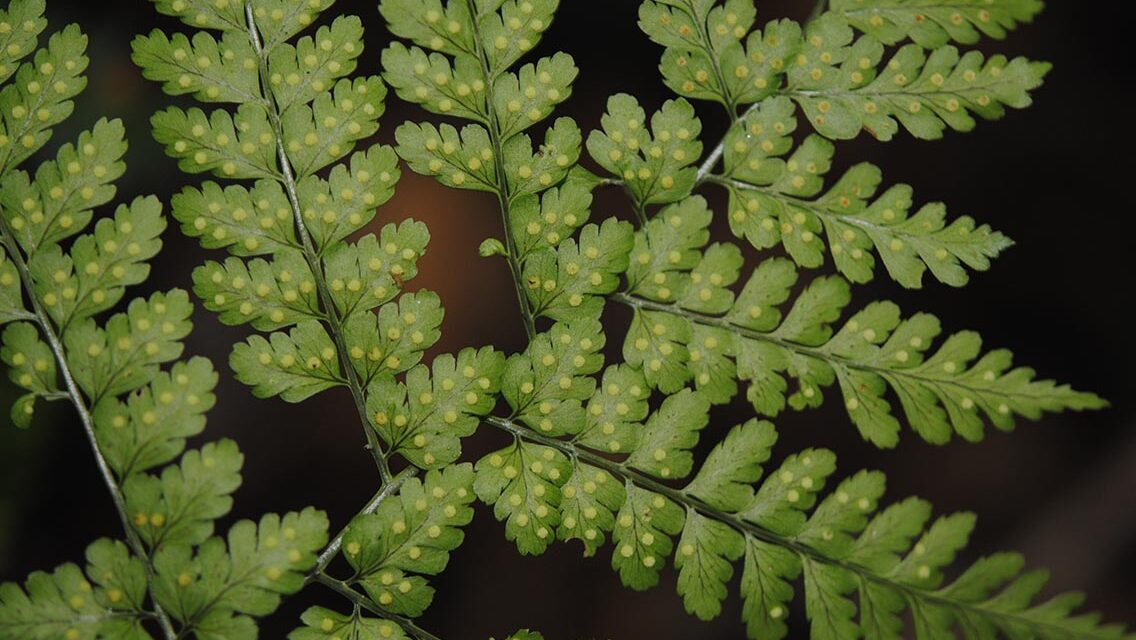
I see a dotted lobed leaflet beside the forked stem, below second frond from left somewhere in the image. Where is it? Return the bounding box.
[343,464,475,617]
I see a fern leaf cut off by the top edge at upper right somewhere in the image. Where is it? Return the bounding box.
[830,0,1043,49]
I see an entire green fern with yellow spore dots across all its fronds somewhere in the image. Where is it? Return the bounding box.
[0,0,1126,640]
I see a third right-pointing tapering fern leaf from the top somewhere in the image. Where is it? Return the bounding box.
[713,98,1011,288]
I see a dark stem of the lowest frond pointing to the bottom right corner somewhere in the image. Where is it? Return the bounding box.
[485,416,1105,640]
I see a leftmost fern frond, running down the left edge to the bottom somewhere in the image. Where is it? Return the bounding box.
[0,0,327,640]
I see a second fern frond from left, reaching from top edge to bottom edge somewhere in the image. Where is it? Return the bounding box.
[134,0,527,639]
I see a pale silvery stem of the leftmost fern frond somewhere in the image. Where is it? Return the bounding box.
[0,217,176,640]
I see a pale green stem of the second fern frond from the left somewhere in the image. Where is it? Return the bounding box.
[245,2,391,485]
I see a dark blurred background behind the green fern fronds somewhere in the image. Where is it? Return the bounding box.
[0,0,1136,640]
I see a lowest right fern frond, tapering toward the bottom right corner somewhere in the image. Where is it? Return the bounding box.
[478,411,1125,639]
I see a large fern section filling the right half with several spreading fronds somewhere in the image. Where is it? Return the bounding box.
[381,0,1124,638]
